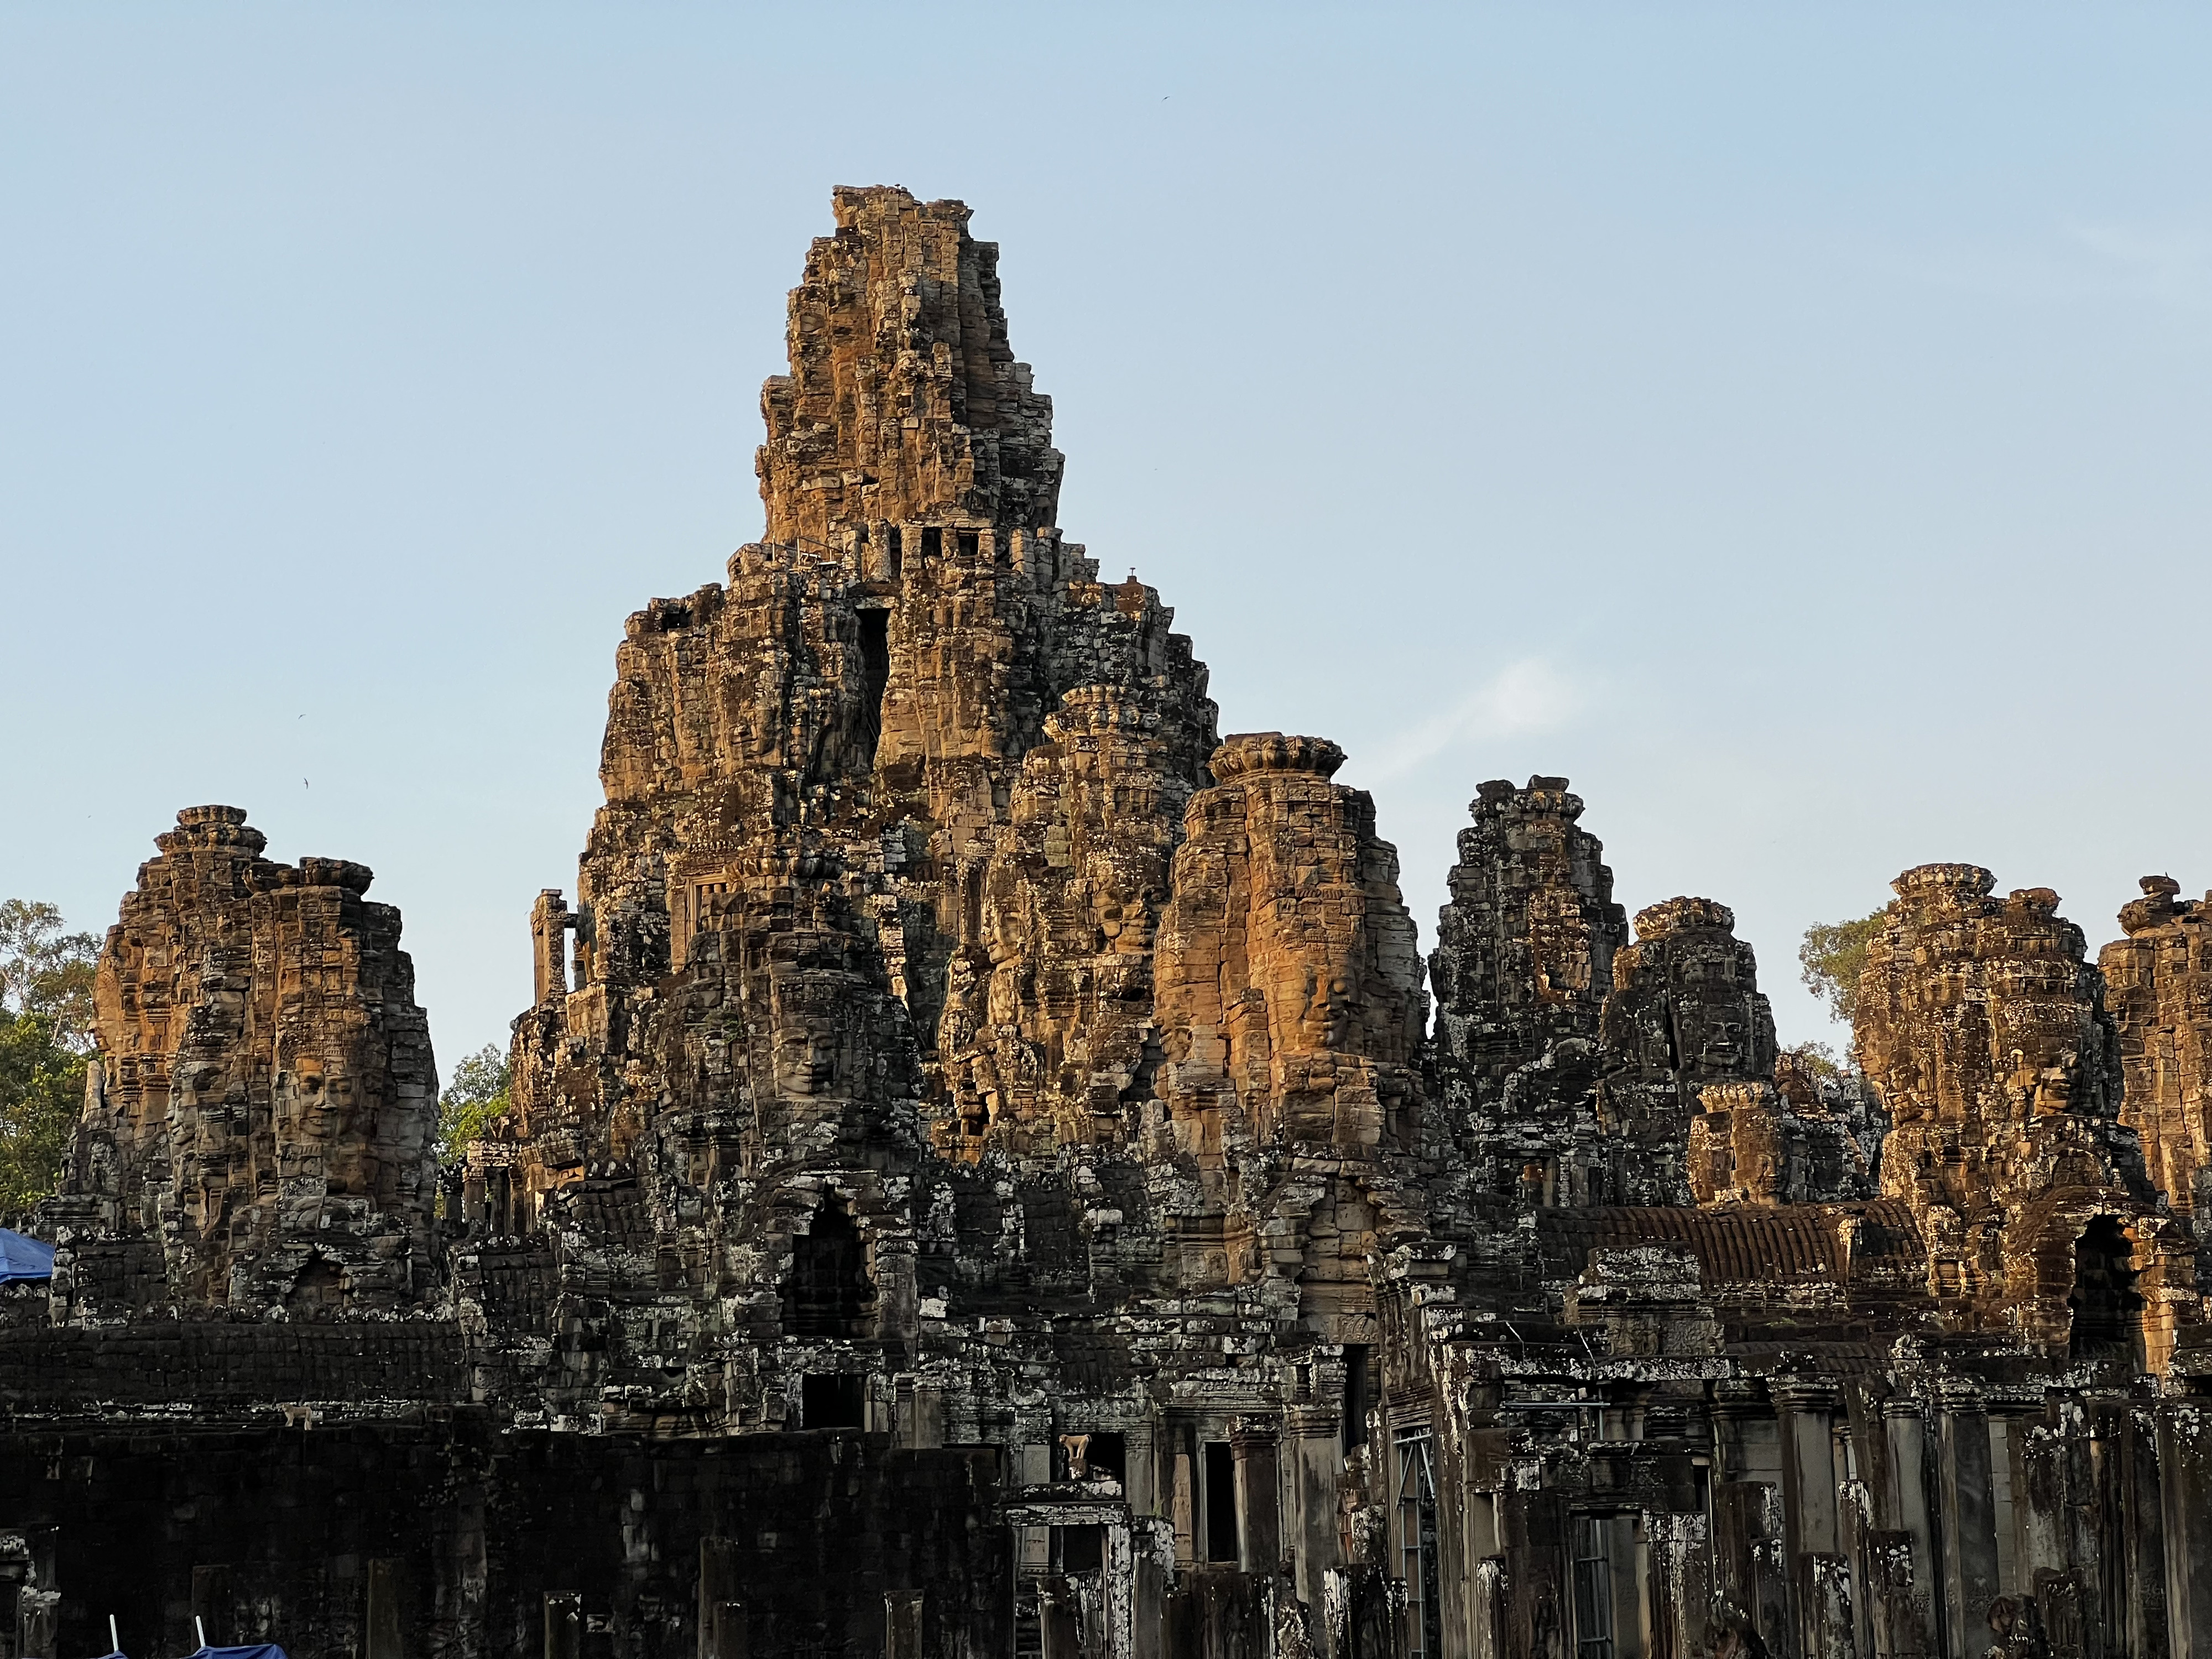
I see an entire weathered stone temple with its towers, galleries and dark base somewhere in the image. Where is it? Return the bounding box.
[0,188,2212,1659]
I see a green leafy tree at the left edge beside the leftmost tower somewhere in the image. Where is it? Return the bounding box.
[0,898,97,1214]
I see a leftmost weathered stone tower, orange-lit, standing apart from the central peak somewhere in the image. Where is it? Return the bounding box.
[62,807,438,1316]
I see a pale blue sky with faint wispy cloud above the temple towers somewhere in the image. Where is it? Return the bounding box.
[0,4,2212,1068]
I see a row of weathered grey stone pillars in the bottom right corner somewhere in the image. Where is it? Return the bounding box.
[1712,1378,2212,1659]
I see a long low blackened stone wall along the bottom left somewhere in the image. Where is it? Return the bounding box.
[0,1411,1011,1659]
